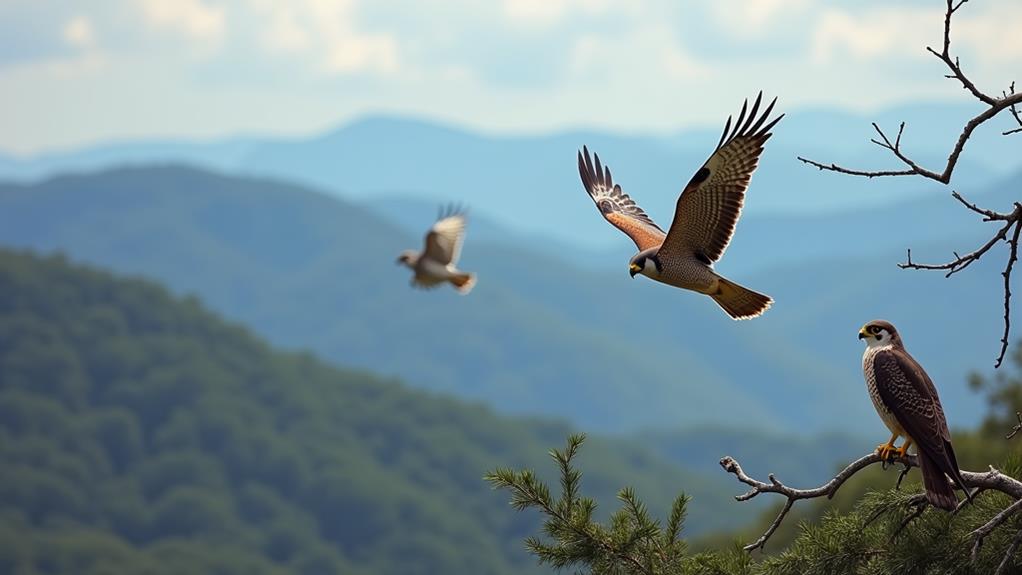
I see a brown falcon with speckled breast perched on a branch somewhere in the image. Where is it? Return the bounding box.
[858,320,972,511]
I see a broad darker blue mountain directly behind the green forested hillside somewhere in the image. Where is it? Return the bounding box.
[0,167,1001,432]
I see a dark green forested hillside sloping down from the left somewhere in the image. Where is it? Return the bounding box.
[0,250,748,575]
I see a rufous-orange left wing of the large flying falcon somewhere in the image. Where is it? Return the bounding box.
[578,146,665,251]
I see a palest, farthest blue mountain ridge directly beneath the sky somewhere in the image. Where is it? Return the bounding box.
[0,101,1022,247]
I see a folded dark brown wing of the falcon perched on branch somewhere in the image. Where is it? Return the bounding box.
[873,349,965,488]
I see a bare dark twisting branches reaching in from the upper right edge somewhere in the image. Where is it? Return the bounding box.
[798,0,1022,368]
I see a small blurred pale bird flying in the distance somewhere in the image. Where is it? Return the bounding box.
[398,207,475,294]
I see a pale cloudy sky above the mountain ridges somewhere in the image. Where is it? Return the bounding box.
[0,0,1022,154]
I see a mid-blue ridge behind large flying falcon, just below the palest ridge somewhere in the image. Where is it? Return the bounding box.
[363,171,1022,274]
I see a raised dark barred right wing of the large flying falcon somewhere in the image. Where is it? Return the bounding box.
[662,92,784,263]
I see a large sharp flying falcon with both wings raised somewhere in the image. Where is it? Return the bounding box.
[578,92,784,320]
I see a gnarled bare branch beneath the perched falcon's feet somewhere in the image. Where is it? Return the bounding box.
[721,452,1022,552]
